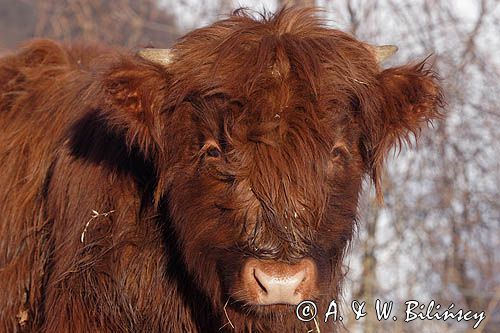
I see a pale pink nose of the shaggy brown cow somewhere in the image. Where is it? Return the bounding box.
[243,259,316,305]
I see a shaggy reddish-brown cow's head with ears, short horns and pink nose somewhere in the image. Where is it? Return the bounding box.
[88,9,441,328]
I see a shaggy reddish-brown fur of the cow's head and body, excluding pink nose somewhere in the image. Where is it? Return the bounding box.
[0,9,441,332]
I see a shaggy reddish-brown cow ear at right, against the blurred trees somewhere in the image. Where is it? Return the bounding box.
[362,62,444,202]
